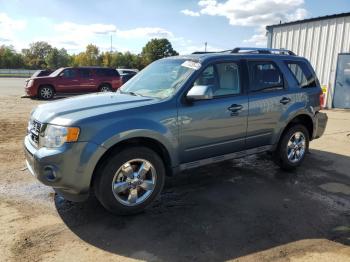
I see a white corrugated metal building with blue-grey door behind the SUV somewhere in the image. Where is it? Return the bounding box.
[266,13,350,108]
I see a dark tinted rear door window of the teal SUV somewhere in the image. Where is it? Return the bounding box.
[248,61,284,92]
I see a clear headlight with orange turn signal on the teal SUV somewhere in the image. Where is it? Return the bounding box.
[40,125,80,148]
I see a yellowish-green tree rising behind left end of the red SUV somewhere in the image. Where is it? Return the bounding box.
[22,41,52,69]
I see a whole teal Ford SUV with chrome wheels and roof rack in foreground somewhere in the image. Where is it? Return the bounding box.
[24,48,327,214]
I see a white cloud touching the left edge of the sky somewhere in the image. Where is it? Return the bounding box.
[0,13,27,44]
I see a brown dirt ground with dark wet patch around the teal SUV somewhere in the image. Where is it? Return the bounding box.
[0,79,350,262]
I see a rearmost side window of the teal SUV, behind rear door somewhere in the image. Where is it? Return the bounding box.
[284,61,317,88]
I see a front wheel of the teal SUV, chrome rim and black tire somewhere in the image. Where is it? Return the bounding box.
[93,147,165,215]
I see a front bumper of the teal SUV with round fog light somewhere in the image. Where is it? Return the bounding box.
[24,136,105,201]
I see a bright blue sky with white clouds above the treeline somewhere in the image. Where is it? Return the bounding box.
[0,0,350,54]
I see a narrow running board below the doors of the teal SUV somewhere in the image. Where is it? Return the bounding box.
[180,145,272,171]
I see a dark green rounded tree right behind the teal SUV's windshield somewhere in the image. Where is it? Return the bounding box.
[141,38,178,64]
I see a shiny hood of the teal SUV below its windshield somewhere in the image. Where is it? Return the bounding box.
[31,93,158,125]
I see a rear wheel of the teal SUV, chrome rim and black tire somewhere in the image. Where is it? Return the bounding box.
[274,124,310,170]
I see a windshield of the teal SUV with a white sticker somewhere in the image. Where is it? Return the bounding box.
[120,59,200,99]
